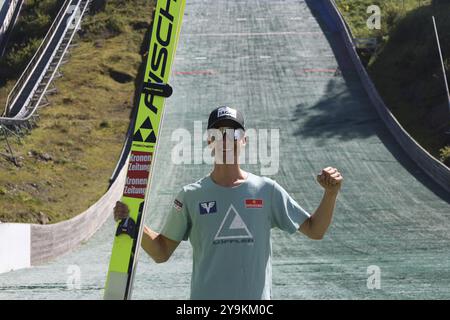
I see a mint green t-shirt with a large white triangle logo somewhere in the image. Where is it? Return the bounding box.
[161,173,310,300]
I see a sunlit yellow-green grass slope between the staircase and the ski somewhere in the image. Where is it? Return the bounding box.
[0,0,154,223]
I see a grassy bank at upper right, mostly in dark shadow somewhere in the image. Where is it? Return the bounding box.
[338,0,450,164]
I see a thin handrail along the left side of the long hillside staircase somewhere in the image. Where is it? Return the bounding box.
[3,0,71,116]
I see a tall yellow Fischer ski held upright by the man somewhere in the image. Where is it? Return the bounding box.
[104,0,185,300]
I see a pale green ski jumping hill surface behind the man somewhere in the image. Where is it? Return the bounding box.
[0,0,450,299]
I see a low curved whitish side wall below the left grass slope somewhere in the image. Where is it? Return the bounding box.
[0,165,127,273]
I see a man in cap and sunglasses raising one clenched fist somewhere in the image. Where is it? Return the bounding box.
[114,107,343,299]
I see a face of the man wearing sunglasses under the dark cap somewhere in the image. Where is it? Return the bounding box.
[208,121,246,164]
